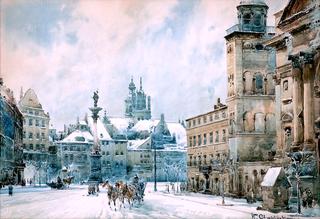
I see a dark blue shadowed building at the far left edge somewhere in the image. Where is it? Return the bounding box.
[0,77,25,188]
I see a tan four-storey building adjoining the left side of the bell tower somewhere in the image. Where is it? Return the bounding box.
[186,98,231,194]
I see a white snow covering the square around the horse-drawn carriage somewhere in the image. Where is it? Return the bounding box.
[0,183,314,219]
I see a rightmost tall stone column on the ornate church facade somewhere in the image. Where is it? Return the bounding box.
[300,52,315,151]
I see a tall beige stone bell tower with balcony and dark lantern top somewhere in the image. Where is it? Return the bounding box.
[225,0,276,198]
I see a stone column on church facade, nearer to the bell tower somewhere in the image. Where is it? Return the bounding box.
[289,55,304,151]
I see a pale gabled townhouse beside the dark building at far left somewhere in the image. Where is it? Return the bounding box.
[19,89,51,183]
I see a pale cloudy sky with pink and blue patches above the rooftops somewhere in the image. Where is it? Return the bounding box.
[0,0,287,129]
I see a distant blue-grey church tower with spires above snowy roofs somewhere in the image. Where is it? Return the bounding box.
[125,78,151,120]
